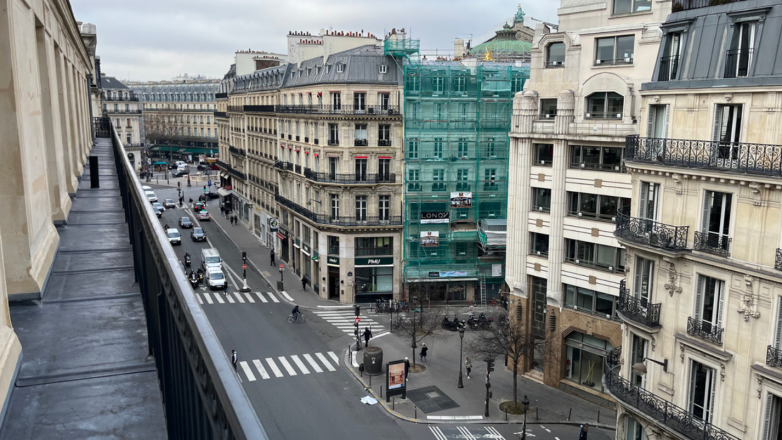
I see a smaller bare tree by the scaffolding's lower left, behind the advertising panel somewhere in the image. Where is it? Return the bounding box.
[394,283,443,365]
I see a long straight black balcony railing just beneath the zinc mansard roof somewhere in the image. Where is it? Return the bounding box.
[625,136,782,176]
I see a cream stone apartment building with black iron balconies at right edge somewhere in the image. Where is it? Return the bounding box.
[604,0,782,440]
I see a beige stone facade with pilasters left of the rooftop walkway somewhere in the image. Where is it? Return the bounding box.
[0,0,100,417]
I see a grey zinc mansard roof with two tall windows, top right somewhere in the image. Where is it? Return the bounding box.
[641,0,782,90]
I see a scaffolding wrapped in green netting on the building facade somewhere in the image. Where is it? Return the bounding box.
[397,51,529,299]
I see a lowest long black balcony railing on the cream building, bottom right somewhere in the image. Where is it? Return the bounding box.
[603,349,739,440]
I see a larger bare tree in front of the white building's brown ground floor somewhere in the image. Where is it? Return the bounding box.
[467,311,545,406]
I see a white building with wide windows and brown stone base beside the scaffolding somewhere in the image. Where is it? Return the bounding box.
[505,0,671,407]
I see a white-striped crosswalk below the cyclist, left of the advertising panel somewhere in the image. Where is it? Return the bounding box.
[239,351,339,382]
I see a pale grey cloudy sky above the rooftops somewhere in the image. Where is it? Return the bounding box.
[71,0,560,81]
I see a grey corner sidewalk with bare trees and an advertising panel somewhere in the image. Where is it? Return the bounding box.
[347,324,616,429]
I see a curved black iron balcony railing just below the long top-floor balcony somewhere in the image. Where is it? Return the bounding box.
[614,206,689,251]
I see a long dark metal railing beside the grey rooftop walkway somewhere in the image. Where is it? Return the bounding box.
[106,118,267,440]
